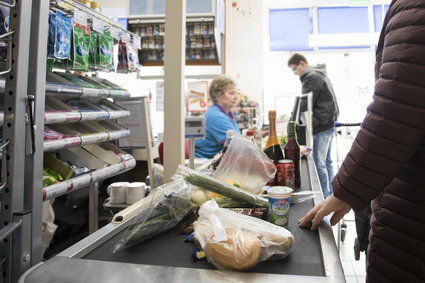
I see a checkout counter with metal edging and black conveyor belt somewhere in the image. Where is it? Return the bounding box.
[19,156,345,283]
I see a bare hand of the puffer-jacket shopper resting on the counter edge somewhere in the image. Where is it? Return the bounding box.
[298,194,351,230]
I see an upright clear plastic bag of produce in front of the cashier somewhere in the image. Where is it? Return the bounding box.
[214,134,276,194]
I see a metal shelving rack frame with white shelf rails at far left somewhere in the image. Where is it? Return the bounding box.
[0,0,139,283]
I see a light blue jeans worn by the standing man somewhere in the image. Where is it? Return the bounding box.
[313,127,335,198]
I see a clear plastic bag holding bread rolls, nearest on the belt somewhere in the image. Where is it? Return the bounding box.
[194,200,295,270]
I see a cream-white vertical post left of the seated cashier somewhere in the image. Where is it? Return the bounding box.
[164,0,186,182]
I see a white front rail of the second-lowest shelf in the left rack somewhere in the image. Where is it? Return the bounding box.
[44,129,130,152]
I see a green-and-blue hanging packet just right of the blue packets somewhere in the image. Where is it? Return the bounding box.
[72,24,90,71]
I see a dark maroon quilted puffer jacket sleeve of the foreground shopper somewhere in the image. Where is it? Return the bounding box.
[332,0,425,210]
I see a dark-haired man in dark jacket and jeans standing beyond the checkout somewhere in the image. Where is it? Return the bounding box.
[288,53,339,198]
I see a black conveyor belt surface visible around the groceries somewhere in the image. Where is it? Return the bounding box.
[84,160,325,276]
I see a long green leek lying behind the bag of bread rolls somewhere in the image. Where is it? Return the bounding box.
[185,170,268,207]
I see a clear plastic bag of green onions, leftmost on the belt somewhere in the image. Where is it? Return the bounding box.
[113,180,194,253]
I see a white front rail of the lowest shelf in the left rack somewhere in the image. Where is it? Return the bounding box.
[43,154,136,200]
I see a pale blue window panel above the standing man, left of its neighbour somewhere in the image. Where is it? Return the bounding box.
[269,8,313,51]
